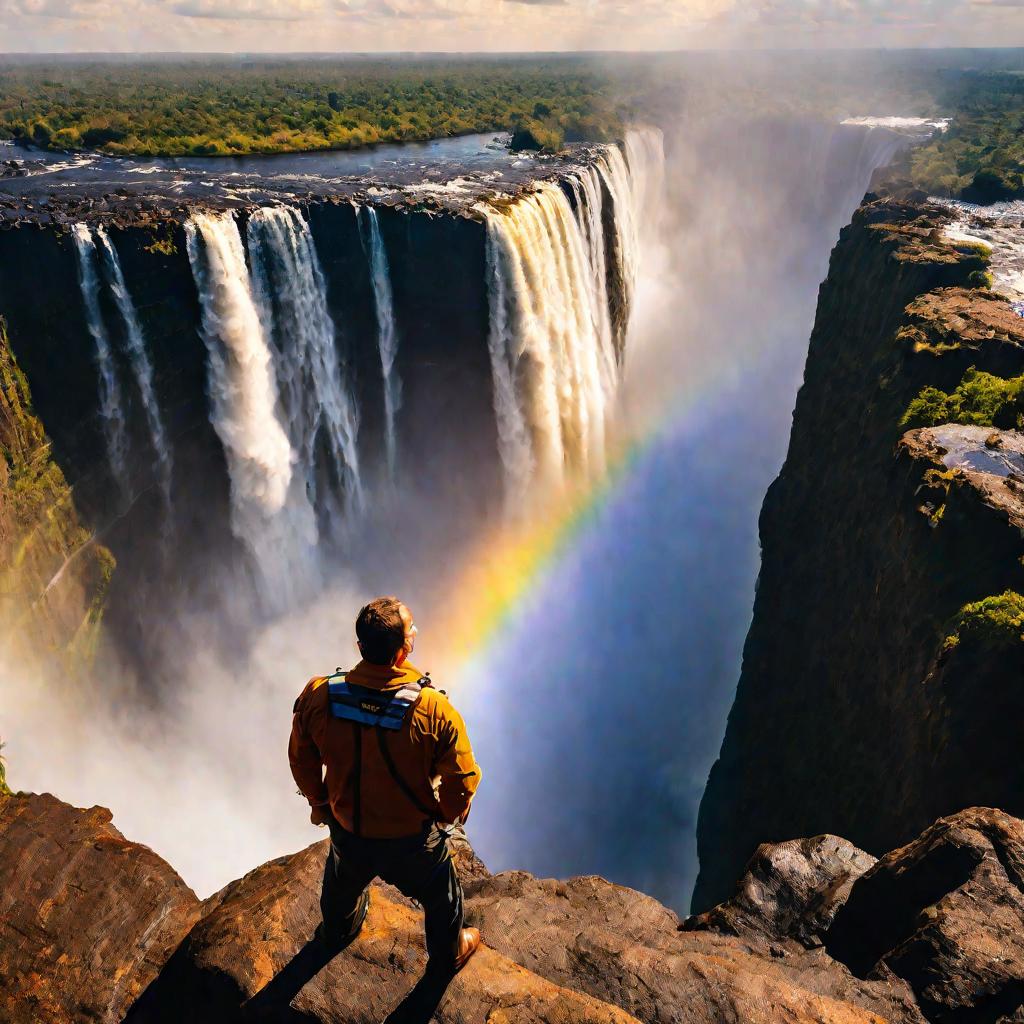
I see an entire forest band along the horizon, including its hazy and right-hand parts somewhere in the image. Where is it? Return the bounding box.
[0,50,1024,202]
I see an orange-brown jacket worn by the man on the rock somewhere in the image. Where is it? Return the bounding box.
[288,662,480,839]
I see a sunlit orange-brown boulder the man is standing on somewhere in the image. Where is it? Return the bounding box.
[128,841,636,1024]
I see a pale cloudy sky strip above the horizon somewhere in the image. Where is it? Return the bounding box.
[0,0,1024,53]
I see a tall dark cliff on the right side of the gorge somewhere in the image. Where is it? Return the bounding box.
[693,195,1024,910]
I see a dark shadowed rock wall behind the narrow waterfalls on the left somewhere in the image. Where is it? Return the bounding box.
[0,202,500,672]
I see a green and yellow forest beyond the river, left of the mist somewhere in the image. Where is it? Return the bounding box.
[0,57,621,157]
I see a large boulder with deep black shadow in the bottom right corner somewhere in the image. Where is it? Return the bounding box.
[825,807,1024,1024]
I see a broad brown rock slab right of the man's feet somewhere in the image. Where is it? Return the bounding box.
[467,871,924,1024]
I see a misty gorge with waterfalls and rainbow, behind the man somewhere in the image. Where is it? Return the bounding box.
[0,114,942,907]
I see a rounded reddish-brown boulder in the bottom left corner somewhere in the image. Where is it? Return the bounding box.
[0,794,200,1024]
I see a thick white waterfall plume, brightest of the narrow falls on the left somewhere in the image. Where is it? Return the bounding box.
[185,213,316,608]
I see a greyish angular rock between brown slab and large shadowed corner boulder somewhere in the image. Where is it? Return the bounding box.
[680,836,876,948]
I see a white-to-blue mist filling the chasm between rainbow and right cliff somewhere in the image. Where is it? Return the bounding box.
[461,116,905,910]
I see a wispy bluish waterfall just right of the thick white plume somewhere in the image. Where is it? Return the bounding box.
[247,206,365,529]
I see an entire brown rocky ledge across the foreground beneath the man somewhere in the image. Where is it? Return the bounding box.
[0,795,1024,1024]
